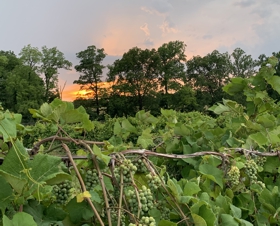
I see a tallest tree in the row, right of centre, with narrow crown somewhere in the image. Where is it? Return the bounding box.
[157,41,186,94]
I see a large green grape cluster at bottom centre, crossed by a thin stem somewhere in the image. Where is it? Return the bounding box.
[127,186,154,216]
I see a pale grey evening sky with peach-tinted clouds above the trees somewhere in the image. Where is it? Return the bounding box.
[0,0,280,100]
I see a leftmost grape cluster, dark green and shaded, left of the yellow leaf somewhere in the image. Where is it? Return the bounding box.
[53,181,72,205]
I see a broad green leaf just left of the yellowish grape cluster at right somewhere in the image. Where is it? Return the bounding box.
[199,164,224,188]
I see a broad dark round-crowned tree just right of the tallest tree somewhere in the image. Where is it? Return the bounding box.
[186,50,230,110]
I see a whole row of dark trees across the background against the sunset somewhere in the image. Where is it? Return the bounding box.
[0,41,280,122]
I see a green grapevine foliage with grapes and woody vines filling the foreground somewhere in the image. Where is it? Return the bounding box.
[0,46,280,226]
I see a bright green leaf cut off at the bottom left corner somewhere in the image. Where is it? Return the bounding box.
[3,212,37,226]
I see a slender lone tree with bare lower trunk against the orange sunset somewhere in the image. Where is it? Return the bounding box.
[74,45,106,115]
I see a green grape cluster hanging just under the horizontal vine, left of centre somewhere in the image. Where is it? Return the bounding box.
[114,159,137,183]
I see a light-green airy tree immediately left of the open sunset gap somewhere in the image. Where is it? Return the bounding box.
[39,46,72,101]
